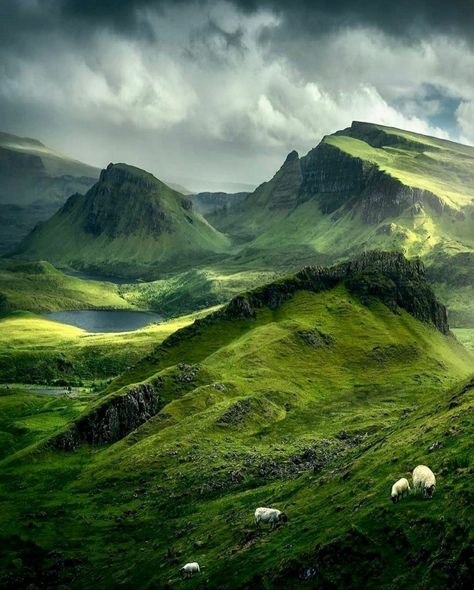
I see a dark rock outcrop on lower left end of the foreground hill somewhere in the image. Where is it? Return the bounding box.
[50,382,161,450]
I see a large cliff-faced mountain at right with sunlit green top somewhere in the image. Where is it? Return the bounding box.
[208,122,474,325]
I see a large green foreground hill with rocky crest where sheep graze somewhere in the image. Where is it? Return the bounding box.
[0,252,474,590]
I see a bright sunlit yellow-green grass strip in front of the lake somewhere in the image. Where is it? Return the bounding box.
[0,312,211,383]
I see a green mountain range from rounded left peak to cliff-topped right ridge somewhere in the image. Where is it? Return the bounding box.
[9,122,474,322]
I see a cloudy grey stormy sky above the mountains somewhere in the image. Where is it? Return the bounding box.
[0,0,474,190]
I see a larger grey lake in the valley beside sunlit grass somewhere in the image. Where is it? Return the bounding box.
[41,310,163,332]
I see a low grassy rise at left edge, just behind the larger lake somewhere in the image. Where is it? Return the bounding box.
[0,261,132,312]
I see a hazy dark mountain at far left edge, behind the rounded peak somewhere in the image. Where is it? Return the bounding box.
[0,132,99,252]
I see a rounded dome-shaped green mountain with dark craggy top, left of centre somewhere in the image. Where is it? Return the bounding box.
[17,164,227,277]
